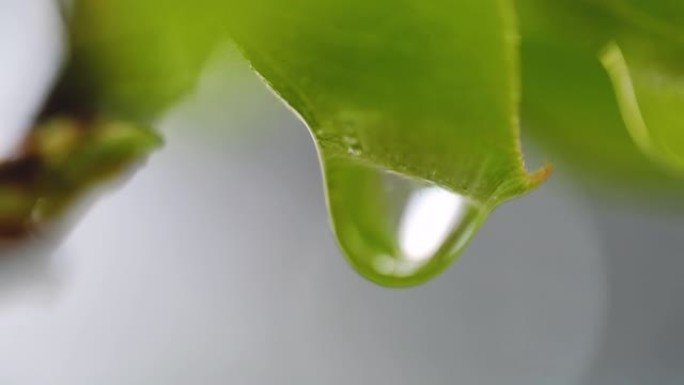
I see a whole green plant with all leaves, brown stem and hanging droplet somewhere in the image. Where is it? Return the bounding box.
[0,0,684,286]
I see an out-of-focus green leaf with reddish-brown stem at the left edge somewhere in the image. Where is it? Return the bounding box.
[0,0,224,237]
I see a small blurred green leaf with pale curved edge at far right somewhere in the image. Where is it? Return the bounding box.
[602,34,684,175]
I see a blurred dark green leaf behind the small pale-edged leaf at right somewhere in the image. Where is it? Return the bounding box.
[517,0,683,192]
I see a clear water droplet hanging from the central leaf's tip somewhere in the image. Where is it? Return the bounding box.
[324,158,488,287]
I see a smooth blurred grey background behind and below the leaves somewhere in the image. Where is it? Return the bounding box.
[0,0,684,385]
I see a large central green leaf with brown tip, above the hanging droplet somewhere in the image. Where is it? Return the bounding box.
[230,0,539,203]
